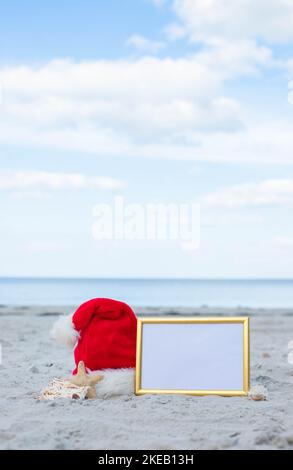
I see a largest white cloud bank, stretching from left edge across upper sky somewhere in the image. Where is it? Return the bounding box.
[0,42,271,159]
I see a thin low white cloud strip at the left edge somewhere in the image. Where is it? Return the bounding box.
[0,170,123,194]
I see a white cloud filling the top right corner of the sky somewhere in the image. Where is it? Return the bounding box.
[173,0,293,43]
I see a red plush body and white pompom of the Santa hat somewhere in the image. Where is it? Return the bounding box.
[52,298,137,374]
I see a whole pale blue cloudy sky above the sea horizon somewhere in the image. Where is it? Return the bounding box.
[0,0,293,278]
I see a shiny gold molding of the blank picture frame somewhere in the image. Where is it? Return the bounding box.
[135,317,250,397]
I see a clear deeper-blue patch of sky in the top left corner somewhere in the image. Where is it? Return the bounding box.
[0,0,175,63]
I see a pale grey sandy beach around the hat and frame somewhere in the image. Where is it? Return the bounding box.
[0,306,293,450]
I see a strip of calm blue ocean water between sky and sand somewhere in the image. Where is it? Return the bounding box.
[0,278,293,308]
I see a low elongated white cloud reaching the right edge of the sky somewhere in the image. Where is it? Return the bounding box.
[202,179,293,209]
